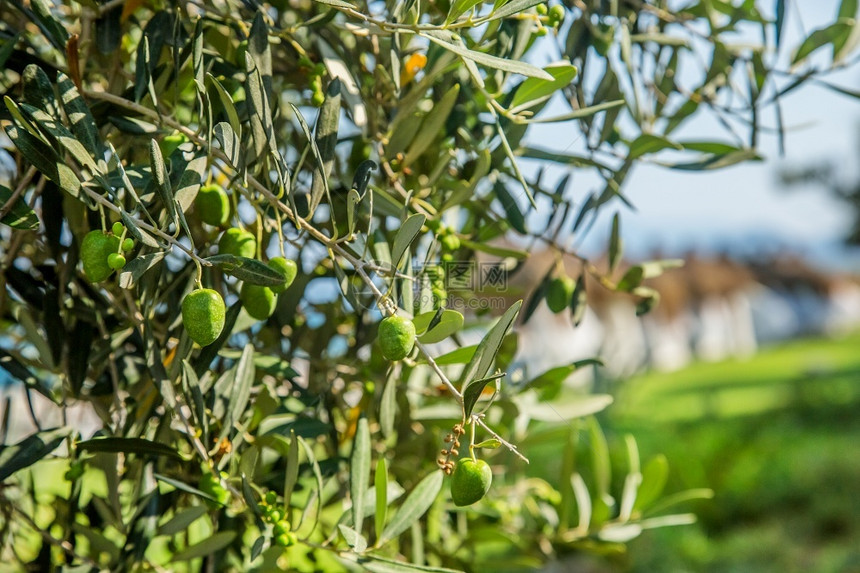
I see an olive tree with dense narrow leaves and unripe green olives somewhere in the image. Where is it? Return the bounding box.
[0,0,856,571]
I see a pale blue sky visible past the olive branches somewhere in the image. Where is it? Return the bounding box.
[516,0,860,269]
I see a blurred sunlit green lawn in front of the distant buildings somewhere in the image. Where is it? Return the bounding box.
[603,334,860,573]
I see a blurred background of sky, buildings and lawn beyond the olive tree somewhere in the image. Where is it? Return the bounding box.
[521,0,860,572]
